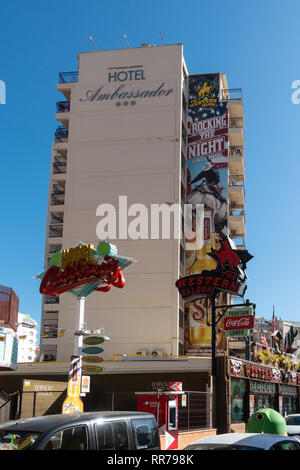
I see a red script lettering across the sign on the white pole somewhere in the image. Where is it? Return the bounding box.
[40,256,125,295]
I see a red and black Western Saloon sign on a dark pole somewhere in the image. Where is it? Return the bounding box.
[176,237,252,302]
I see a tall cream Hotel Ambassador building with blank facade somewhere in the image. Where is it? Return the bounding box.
[40,44,245,360]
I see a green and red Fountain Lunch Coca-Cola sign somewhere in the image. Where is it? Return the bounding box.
[223,306,254,336]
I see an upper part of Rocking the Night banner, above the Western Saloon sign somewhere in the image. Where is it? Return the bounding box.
[185,74,228,275]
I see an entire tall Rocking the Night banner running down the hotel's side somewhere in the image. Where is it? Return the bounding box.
[181,73,228,355]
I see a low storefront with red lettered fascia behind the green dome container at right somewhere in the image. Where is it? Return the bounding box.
[227,358,300,429]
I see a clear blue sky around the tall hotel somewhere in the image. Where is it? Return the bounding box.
[0,0,300,338]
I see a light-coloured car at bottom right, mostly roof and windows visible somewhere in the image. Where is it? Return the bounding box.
[184,433,300,451]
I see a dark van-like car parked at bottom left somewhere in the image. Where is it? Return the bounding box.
[0,411,160,451]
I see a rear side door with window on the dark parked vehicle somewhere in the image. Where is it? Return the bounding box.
[95,420,130,451]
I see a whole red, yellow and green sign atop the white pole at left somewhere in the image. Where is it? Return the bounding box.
[35,241,134,298]
